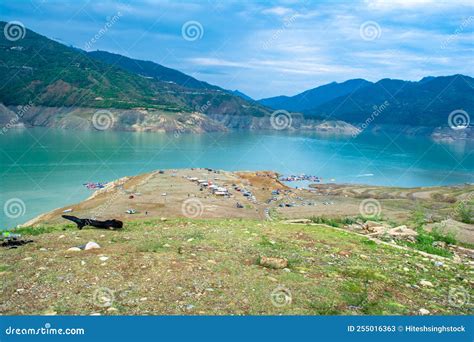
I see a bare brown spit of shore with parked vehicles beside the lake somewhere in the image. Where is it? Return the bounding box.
[22,169,474,244]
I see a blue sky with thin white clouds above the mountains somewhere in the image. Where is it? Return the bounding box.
[0,0,474,99]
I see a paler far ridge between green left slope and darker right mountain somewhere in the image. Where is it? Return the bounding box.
[258,79,372,112]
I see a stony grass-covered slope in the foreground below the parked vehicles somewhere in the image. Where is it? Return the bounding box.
[0,219,473,315]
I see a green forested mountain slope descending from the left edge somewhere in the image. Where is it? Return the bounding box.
[0,22,268,116]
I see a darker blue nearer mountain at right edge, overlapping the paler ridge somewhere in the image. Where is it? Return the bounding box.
[306,75,474,127]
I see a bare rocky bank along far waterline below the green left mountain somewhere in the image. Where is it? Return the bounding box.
[0,106,358,134]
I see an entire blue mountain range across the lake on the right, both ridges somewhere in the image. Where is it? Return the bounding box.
[258,75,474,127]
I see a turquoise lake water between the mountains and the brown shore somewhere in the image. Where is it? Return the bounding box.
[0,128,474,229]
